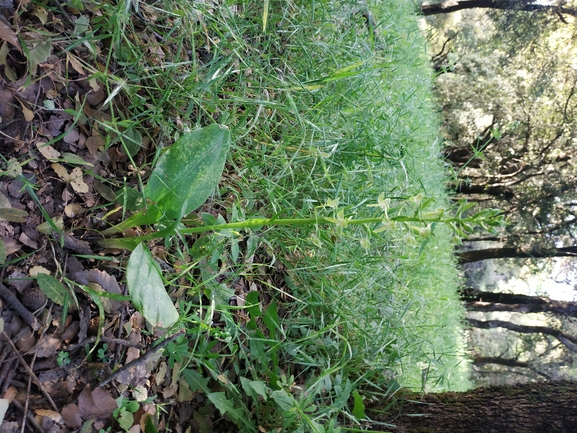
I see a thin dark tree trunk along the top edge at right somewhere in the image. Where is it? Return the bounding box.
[421,0,577,16]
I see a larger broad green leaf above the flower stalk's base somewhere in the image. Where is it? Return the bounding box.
[144,124,230,220]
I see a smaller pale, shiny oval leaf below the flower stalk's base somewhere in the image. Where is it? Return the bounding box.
[126,244,178,328]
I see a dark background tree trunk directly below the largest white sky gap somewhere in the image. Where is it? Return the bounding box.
[461,289,577,317]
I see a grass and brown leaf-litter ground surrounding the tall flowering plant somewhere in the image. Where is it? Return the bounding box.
[0,0,468,432]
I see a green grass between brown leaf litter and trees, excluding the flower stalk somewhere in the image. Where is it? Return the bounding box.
[99,1,468,431]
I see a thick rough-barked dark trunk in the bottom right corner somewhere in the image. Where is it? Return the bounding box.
[367,381,577,433]
